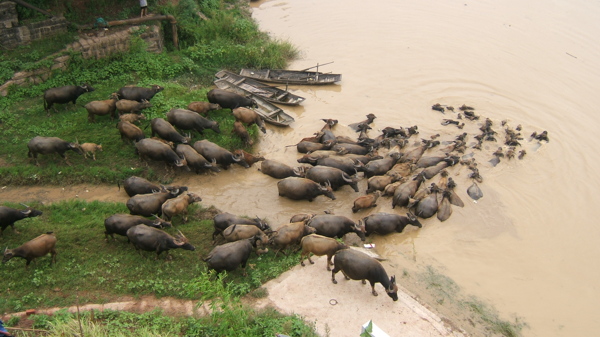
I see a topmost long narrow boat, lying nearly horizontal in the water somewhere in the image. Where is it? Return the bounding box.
[240,69,342,85]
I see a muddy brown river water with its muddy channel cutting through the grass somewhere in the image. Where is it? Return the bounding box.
[0,0,600,337]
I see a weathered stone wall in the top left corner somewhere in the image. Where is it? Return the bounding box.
[0,1,68,49]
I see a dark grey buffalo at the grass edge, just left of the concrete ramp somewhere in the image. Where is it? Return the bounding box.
[202,235,268,276]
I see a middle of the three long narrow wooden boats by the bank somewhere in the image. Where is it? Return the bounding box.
[215,70,305,105]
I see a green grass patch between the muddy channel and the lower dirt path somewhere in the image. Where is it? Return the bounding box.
[0,200,299,311]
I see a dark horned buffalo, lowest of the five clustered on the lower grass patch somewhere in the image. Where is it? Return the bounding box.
[127,225,196,260]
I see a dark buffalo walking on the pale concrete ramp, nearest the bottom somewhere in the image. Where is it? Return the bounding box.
[331,249,398,301]
